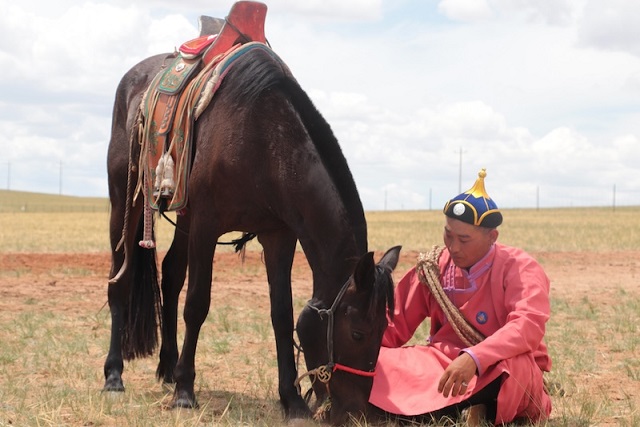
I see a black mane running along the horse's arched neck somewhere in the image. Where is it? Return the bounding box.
[222,49,367,254]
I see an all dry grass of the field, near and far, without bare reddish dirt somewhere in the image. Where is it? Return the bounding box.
[0,191,640,426]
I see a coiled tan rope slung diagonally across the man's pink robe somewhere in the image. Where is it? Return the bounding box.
[416,245,485,347]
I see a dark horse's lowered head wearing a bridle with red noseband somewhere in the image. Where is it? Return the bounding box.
[297,246,400,425]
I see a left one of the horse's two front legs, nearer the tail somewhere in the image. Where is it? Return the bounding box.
[173,224,217,408]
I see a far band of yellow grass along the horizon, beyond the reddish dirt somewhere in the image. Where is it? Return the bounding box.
[0,201,640,252]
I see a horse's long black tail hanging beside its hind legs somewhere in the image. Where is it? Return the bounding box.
[122,227,162,360]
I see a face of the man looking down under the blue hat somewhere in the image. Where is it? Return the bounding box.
[444,217,498,268]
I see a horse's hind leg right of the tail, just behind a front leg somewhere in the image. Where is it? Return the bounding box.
[156,215,189,384]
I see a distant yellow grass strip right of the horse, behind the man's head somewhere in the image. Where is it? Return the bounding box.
[366,207,640,252]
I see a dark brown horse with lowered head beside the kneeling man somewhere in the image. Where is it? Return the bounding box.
[104,17,397,421]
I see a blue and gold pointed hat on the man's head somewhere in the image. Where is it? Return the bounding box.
[443,169,502,228]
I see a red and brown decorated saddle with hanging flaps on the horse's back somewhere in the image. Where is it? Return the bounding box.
[134,1,268,221]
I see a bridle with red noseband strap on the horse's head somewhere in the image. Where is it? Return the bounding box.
[295,276,376,395]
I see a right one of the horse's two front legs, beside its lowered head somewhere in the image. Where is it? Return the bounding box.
[258,230,311,418]
